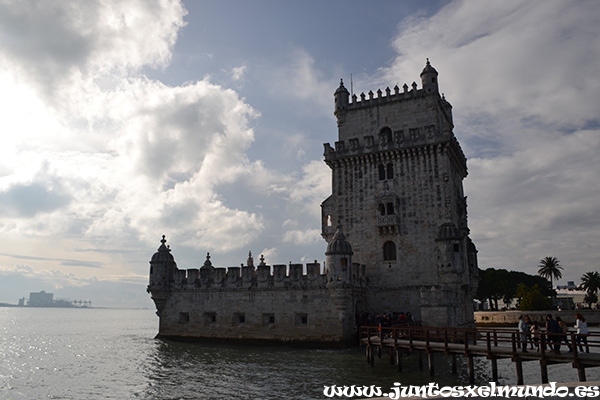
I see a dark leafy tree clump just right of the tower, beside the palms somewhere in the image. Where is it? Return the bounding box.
[475,268,555,310]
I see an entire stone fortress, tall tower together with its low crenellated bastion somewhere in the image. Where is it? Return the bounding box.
[148,60,478,345]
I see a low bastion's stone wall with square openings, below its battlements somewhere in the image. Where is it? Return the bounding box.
[159,286,354,345]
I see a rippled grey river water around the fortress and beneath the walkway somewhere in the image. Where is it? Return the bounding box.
[0,308,600,400]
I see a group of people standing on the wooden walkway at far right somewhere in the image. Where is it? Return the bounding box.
[518,313,590,353]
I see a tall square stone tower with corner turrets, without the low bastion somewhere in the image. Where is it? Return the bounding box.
[321,60,477,326]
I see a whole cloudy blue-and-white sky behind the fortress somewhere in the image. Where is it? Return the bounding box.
[0,0,600,308]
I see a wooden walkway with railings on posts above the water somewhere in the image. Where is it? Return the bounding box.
[359,326,600,385]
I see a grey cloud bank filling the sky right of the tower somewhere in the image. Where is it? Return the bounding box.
[378,1,600,280]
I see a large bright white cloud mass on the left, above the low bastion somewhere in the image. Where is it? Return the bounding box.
[0,1,285,278]
